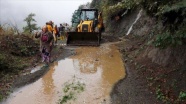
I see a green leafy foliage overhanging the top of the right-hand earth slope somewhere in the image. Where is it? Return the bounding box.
[91,0,186,48]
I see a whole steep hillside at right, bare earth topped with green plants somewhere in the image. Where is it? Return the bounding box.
[91,0,186,103]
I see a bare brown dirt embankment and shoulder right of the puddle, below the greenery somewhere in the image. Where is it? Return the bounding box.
[111,10,186,104]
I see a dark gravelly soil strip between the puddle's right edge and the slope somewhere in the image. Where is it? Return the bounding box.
[111,36,161,104]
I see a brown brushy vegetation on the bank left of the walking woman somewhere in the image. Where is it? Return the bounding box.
[0,15,39,101]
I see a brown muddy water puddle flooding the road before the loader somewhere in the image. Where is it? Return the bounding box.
[4,44,125,104]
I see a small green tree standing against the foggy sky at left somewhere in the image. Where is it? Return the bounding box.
[23,13,38,33]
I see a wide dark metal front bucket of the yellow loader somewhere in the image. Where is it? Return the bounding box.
[67,32,101,46]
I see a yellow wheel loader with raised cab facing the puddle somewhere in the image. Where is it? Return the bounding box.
[67,9,104,46]
